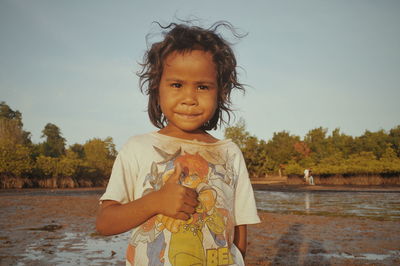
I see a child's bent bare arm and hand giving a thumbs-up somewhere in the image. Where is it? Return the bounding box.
[96,164,198,235]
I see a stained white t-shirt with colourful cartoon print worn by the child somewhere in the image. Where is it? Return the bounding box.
[100,132,260,266]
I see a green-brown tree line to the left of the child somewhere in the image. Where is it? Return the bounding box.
[0,102,117,188]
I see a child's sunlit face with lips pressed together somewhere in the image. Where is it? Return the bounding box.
[159,50,218,133]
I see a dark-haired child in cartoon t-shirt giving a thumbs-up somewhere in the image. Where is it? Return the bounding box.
[96,23,260,266]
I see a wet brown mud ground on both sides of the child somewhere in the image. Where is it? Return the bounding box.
[0,188,400,265]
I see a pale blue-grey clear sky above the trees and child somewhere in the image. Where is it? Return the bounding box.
[0,0,400,149]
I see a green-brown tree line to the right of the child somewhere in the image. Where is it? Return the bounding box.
[225,120,400,177]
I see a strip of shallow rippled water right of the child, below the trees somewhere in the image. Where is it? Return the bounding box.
[254,190,400,220]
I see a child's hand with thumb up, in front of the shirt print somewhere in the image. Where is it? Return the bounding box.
[158,164,199,220]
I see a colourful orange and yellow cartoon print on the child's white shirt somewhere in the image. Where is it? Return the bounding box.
[127,146,236,265]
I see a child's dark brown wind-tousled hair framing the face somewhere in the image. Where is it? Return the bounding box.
[138,21,244,130]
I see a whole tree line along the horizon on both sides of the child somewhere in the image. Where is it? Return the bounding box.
[0,102,400,188]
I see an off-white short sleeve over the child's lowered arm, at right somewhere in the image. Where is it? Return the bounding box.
[234,150,260,225]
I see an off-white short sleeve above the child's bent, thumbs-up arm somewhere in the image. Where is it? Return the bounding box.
[100,145,138,204]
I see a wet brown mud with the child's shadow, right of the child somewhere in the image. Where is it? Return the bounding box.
[246,212,400,265]
